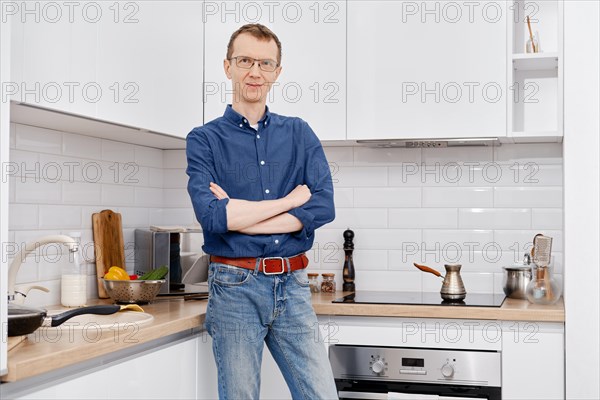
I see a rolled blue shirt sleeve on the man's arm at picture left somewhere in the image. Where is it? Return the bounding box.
[186,128,229,233]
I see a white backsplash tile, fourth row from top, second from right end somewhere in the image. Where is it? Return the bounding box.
[458,208,531,229]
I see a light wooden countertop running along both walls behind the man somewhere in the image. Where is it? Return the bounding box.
[1,292,565,382]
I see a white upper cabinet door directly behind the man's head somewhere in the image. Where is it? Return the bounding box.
[204,1,346,140]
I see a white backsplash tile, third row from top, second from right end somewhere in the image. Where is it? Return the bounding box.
[423,187,494,207]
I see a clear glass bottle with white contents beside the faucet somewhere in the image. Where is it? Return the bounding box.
[60,232,87,307]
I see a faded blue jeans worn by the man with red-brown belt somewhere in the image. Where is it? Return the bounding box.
[205,263,337,400]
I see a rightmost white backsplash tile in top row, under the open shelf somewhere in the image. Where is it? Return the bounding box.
[494,143,562,164]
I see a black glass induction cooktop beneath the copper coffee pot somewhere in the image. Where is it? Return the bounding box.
[333,290,505,307]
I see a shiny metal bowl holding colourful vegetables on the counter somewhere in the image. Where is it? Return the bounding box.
[102,278,166,304]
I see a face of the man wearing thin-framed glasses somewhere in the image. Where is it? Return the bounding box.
[224,33,281,103]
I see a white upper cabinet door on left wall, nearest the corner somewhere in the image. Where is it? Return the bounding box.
[97,1,203,137]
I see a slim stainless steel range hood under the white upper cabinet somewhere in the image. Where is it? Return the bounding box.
[356,138,500,149]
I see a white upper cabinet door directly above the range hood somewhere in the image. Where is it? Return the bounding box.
[347,1,507,140]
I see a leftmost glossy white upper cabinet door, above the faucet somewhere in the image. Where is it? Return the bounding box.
[6,2,96,116]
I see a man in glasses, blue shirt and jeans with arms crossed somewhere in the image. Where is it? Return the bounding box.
[187,24,337,399]
